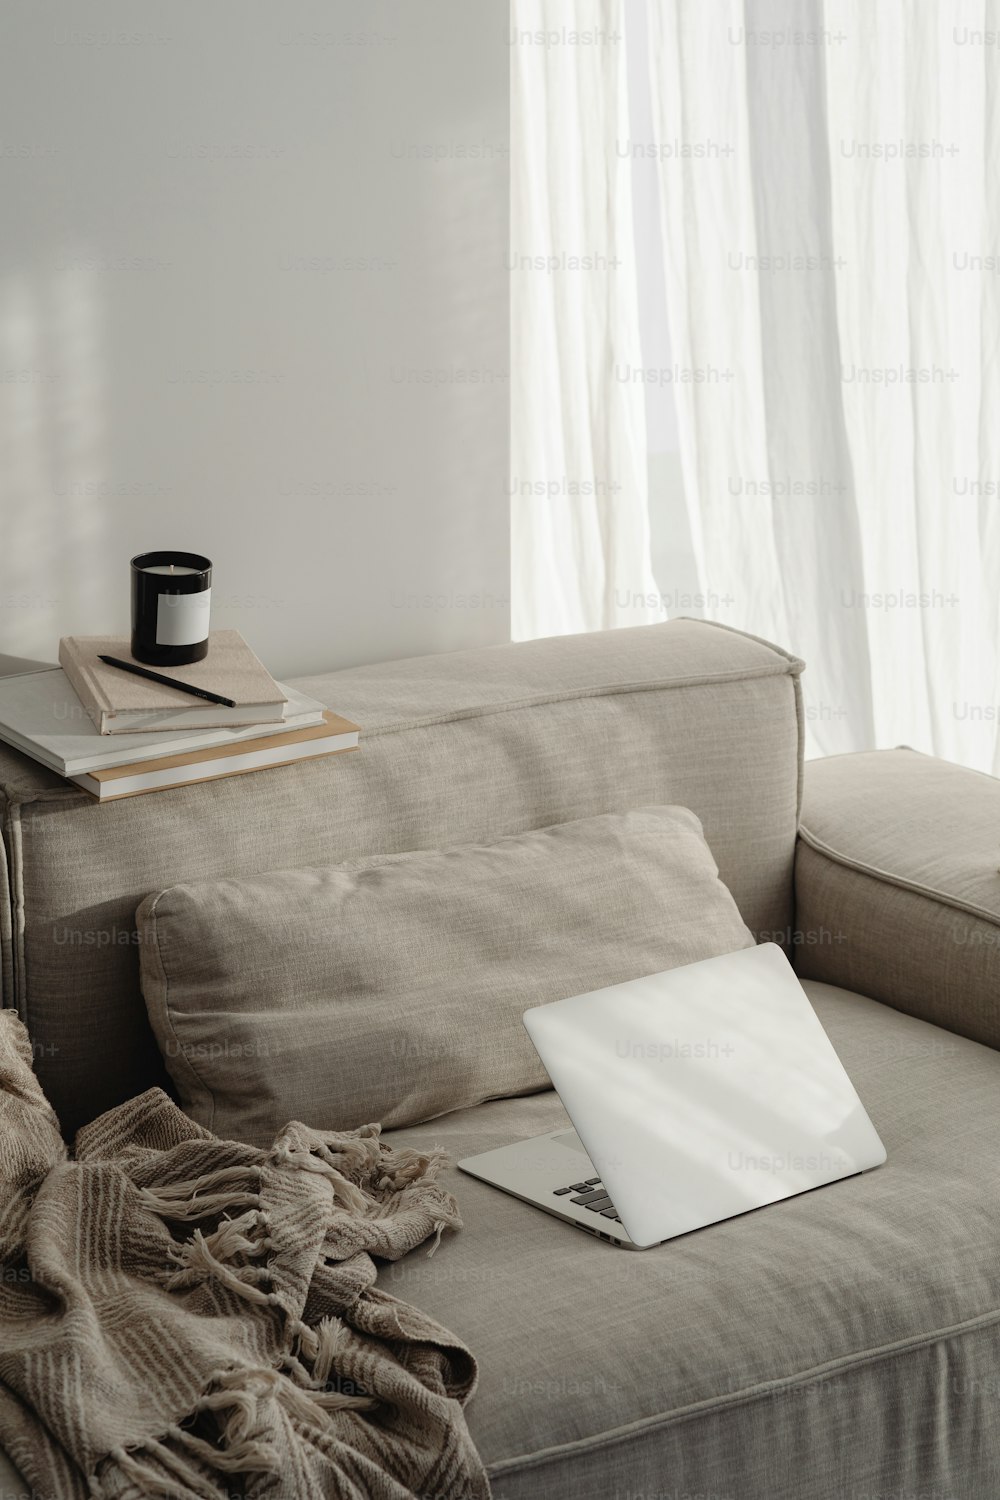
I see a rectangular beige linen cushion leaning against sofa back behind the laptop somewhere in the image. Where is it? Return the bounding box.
[138,807,754,1145]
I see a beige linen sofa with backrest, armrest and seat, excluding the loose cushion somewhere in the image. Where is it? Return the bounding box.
[0,621,1000,1500]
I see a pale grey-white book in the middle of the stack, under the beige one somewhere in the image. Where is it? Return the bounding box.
[0,669,325,777]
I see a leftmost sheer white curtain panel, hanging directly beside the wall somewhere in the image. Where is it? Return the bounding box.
[510,0,663,641]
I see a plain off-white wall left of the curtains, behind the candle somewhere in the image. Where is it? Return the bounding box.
[0,0,510,675]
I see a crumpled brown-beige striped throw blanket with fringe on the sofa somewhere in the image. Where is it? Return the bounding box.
[0,1011,489,1500]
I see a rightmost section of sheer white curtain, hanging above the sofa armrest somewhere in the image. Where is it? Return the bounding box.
[825,0,1000,771]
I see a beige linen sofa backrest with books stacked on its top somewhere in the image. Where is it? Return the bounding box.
[0,620,801,1131]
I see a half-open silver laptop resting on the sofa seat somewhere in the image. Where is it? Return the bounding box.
[459,944,886,1250]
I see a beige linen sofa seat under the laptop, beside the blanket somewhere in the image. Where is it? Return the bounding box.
[381,983,1000,1500]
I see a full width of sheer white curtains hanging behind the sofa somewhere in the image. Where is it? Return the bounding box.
[513,0,1000,773]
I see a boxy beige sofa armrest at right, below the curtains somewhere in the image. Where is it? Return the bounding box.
[795,750,1000,1047]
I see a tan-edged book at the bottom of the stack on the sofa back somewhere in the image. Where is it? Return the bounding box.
[69,710,360,803]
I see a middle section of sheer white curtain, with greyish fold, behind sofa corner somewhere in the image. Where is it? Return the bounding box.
[648,0,874,753]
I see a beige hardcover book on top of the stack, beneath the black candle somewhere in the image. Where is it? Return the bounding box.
[58,630,285,735]
